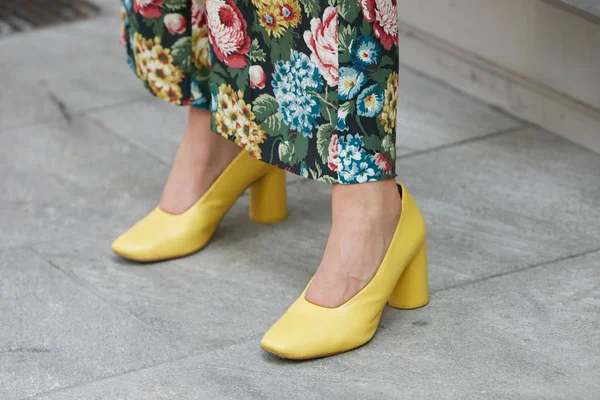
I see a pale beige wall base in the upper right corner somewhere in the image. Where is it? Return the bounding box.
[398,0,600,152]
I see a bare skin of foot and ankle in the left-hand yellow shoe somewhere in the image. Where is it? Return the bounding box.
[159,107,241,214]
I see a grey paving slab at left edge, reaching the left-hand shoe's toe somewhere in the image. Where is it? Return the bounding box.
[0,114,168,247]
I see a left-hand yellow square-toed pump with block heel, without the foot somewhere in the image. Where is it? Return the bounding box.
[112,150,287,262]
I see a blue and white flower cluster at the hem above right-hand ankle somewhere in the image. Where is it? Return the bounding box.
[338,135,381,183]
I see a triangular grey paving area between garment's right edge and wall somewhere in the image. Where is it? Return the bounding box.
[397,68,523,155]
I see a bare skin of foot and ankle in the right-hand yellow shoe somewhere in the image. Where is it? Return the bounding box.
[306,179,402,308]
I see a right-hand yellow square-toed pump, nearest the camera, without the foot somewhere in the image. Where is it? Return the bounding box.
[261,184,429,360]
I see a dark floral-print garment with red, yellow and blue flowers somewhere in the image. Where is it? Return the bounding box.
[122,0,398,184]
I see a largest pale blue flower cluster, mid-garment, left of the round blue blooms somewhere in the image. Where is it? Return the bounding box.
[272,50,323,138]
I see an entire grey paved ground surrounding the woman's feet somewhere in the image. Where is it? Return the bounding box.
[0,0,600,400]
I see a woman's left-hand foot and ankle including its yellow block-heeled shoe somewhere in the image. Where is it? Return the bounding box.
[111,110,287,262]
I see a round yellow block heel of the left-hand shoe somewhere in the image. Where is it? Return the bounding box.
[250,167,287,224]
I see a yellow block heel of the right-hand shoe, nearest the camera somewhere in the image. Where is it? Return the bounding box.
[388,244,429,310]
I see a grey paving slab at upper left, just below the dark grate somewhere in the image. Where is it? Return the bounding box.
[0,15,145,131]
